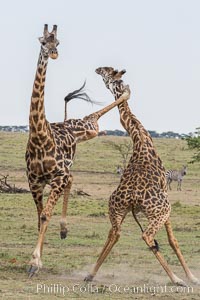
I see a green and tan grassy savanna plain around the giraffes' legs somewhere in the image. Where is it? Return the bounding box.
[0,132,200,300]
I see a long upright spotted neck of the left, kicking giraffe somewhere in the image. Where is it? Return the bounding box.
[29,50,48,135]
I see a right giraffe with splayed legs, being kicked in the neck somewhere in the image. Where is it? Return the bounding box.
[85,67,199,286]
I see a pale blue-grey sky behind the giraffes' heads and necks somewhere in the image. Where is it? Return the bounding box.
[0,0,200,133]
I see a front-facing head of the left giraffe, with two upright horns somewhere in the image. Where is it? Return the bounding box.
[39,24,59,59]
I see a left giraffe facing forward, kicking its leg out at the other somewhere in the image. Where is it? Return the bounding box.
[26,25,129,276]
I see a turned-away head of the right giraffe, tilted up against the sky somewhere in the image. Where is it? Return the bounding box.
[96,67,126,92]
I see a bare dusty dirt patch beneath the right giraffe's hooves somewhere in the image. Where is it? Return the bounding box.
[40,264,200,300]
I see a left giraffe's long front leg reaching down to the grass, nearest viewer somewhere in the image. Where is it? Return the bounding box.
[28,174,69,277]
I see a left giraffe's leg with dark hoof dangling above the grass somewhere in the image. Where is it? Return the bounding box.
[60,175,73,239]
